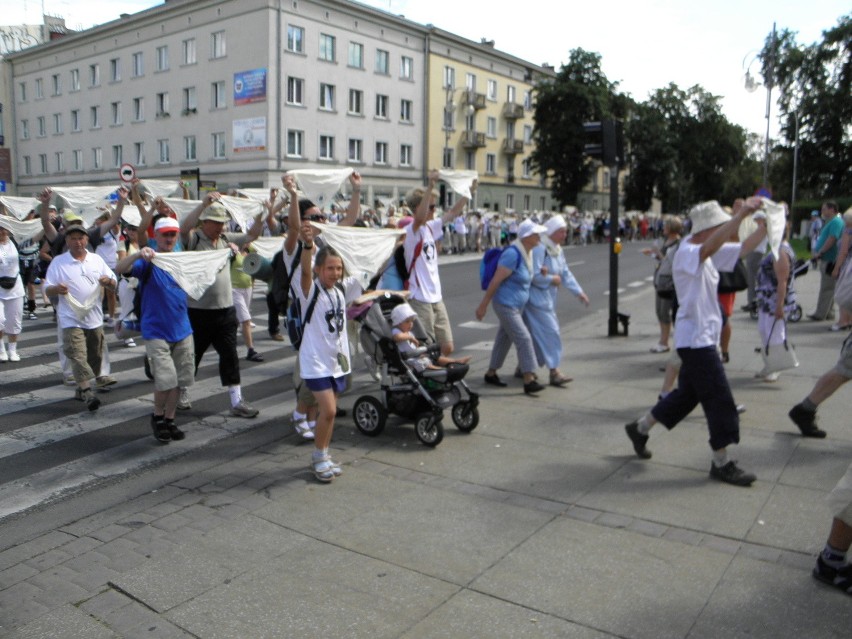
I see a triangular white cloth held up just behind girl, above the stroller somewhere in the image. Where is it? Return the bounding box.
[311,222,405,288]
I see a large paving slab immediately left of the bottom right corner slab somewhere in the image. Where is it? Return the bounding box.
[471,519,730,639]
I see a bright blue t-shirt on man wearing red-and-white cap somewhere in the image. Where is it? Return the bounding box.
[130,258,192,343]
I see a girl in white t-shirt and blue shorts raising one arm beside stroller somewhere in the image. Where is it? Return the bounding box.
[298,222,351,482]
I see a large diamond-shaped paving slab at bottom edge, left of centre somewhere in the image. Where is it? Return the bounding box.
[167,540,458,639]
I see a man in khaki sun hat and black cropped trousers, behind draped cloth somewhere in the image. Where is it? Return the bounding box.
[179,193,263,417]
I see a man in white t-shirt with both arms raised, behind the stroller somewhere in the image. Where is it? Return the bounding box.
[400,170,476,356]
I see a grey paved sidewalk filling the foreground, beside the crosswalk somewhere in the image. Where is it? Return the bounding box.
[0,264,852,639]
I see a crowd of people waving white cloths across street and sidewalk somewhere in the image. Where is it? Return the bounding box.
[0,170,852,592]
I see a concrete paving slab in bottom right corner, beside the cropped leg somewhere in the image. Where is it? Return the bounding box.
[689,557,852,639]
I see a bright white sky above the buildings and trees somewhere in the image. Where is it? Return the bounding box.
[5,0,850,135]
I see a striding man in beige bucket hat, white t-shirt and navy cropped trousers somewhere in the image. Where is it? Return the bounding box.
[625,197,766,486]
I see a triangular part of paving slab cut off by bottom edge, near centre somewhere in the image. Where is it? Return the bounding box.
[401,590,615,639]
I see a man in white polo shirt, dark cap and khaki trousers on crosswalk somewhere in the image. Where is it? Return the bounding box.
[45,224,116,411]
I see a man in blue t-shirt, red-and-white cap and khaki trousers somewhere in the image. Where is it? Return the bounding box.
[115,217,195,444]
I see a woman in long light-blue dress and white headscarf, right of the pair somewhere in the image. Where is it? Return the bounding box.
[524,215,589,387]
